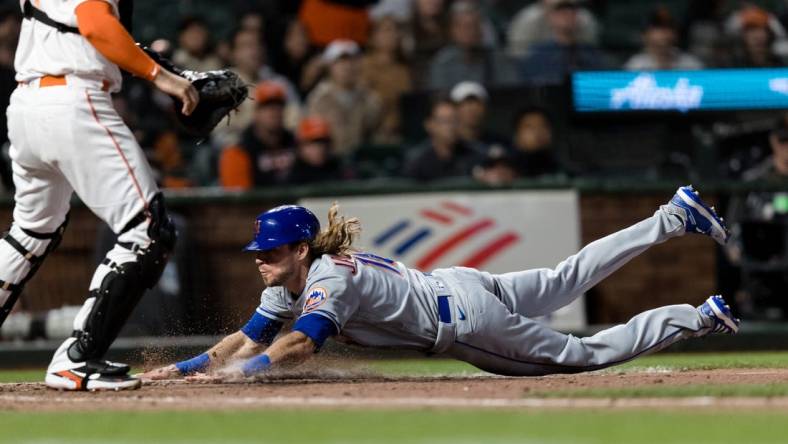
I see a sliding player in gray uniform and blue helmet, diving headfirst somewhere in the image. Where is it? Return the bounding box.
[143,187,739,380]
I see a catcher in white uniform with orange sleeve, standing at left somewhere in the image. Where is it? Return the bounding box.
[0,0,240,390]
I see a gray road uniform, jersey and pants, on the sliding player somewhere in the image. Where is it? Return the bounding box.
[257,205,713,376]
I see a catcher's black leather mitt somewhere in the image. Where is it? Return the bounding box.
[142,48,249,138]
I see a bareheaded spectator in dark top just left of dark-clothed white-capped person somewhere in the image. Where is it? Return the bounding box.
[404,98,482,181]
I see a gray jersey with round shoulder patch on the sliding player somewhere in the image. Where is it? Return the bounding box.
[257,253,438,349]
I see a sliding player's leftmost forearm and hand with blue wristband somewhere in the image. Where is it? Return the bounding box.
[140,331,265,381]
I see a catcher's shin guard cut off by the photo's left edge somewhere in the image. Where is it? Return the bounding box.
[0,215,68,326]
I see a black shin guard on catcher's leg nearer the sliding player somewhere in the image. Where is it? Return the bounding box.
[68,194,177,362]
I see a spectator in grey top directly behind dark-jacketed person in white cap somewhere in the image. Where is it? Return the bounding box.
[429,0,516,90]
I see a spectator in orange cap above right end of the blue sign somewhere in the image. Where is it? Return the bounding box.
[729,6,785,68]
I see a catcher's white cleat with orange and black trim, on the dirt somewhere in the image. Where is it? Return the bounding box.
[44,361,142,391]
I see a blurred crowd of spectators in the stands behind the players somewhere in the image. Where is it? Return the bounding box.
[0,0,788,189]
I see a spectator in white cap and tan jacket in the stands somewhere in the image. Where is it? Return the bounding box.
[307,40,381,155]
